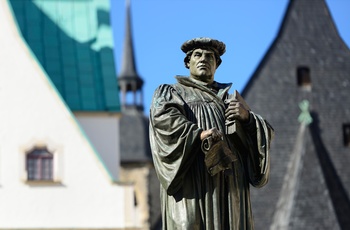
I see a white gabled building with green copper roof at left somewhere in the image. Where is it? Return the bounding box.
[0,0,141,229]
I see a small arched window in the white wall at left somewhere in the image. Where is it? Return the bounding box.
[26,147,54,181]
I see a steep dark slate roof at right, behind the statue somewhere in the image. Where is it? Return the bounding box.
[242,0,350,229]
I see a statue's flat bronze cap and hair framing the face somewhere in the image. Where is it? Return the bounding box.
[181,37,226,69]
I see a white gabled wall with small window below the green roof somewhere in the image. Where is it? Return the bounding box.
[0,0,139,229]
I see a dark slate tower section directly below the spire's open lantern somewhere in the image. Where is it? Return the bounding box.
[120,106,152,164]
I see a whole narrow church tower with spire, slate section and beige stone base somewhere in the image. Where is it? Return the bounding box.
[118,0,161,229]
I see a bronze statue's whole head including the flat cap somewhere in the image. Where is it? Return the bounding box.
[181,38,226,83]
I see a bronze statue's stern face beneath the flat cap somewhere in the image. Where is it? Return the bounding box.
[188,49,216,83]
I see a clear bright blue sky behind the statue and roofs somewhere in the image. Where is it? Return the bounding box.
[111,0,350,114]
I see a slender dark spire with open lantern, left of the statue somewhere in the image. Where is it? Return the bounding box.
[118,0,143,110]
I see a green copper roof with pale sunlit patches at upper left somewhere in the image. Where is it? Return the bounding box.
[9,0,120,112]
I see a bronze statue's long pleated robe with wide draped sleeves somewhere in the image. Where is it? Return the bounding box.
[150,76,273,230]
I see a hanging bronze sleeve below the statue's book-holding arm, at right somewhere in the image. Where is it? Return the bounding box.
[245,112,274,187]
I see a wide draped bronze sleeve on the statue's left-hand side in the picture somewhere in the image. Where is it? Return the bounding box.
[149,85,202,195]
